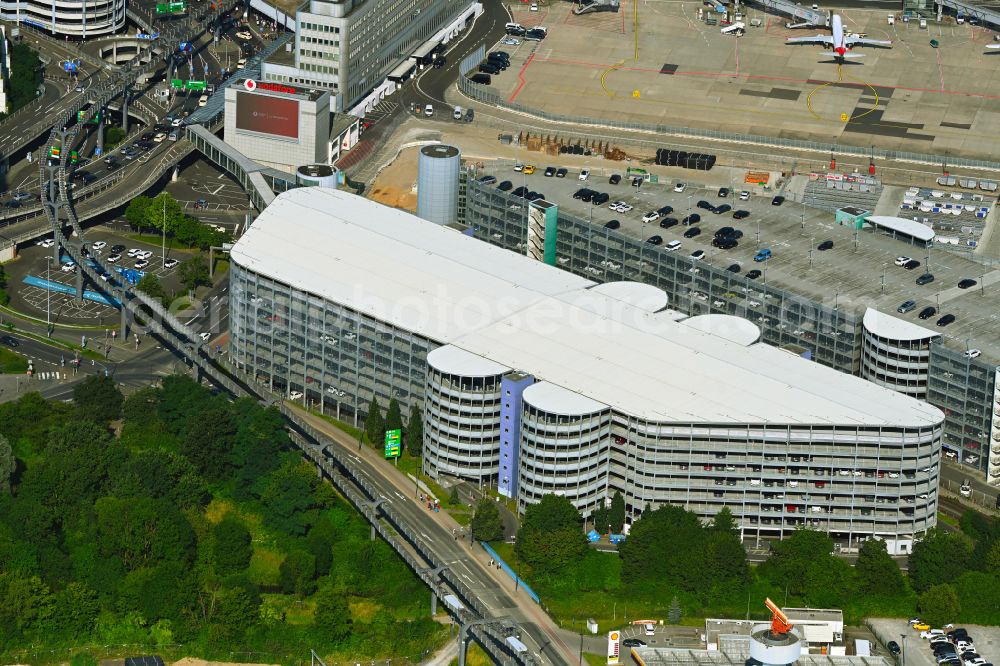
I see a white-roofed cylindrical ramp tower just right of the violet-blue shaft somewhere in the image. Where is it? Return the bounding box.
[518,382,611,516]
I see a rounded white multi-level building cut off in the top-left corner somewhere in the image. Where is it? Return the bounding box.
[0,0,125,39]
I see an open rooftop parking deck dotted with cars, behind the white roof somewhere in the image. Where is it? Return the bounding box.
[472,160,1000,356]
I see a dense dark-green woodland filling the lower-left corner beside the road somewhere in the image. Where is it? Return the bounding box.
[0,377,445,663]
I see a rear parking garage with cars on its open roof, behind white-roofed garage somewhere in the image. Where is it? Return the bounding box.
[460,171,1000,484]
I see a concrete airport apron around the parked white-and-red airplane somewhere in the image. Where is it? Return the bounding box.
[496,0,1000,161]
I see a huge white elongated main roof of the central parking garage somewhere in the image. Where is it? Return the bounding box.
[231,187,944,427]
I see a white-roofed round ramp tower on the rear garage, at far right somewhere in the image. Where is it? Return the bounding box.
[861,308,940,399]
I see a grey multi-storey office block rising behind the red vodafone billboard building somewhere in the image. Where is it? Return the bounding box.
[261,0,482,115]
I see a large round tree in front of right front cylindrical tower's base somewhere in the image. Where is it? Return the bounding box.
[515,494,587,576]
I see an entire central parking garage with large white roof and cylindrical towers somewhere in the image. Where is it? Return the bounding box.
[231,188,944,553]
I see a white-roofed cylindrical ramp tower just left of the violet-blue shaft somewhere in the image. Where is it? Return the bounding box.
[424,345,510,483]
